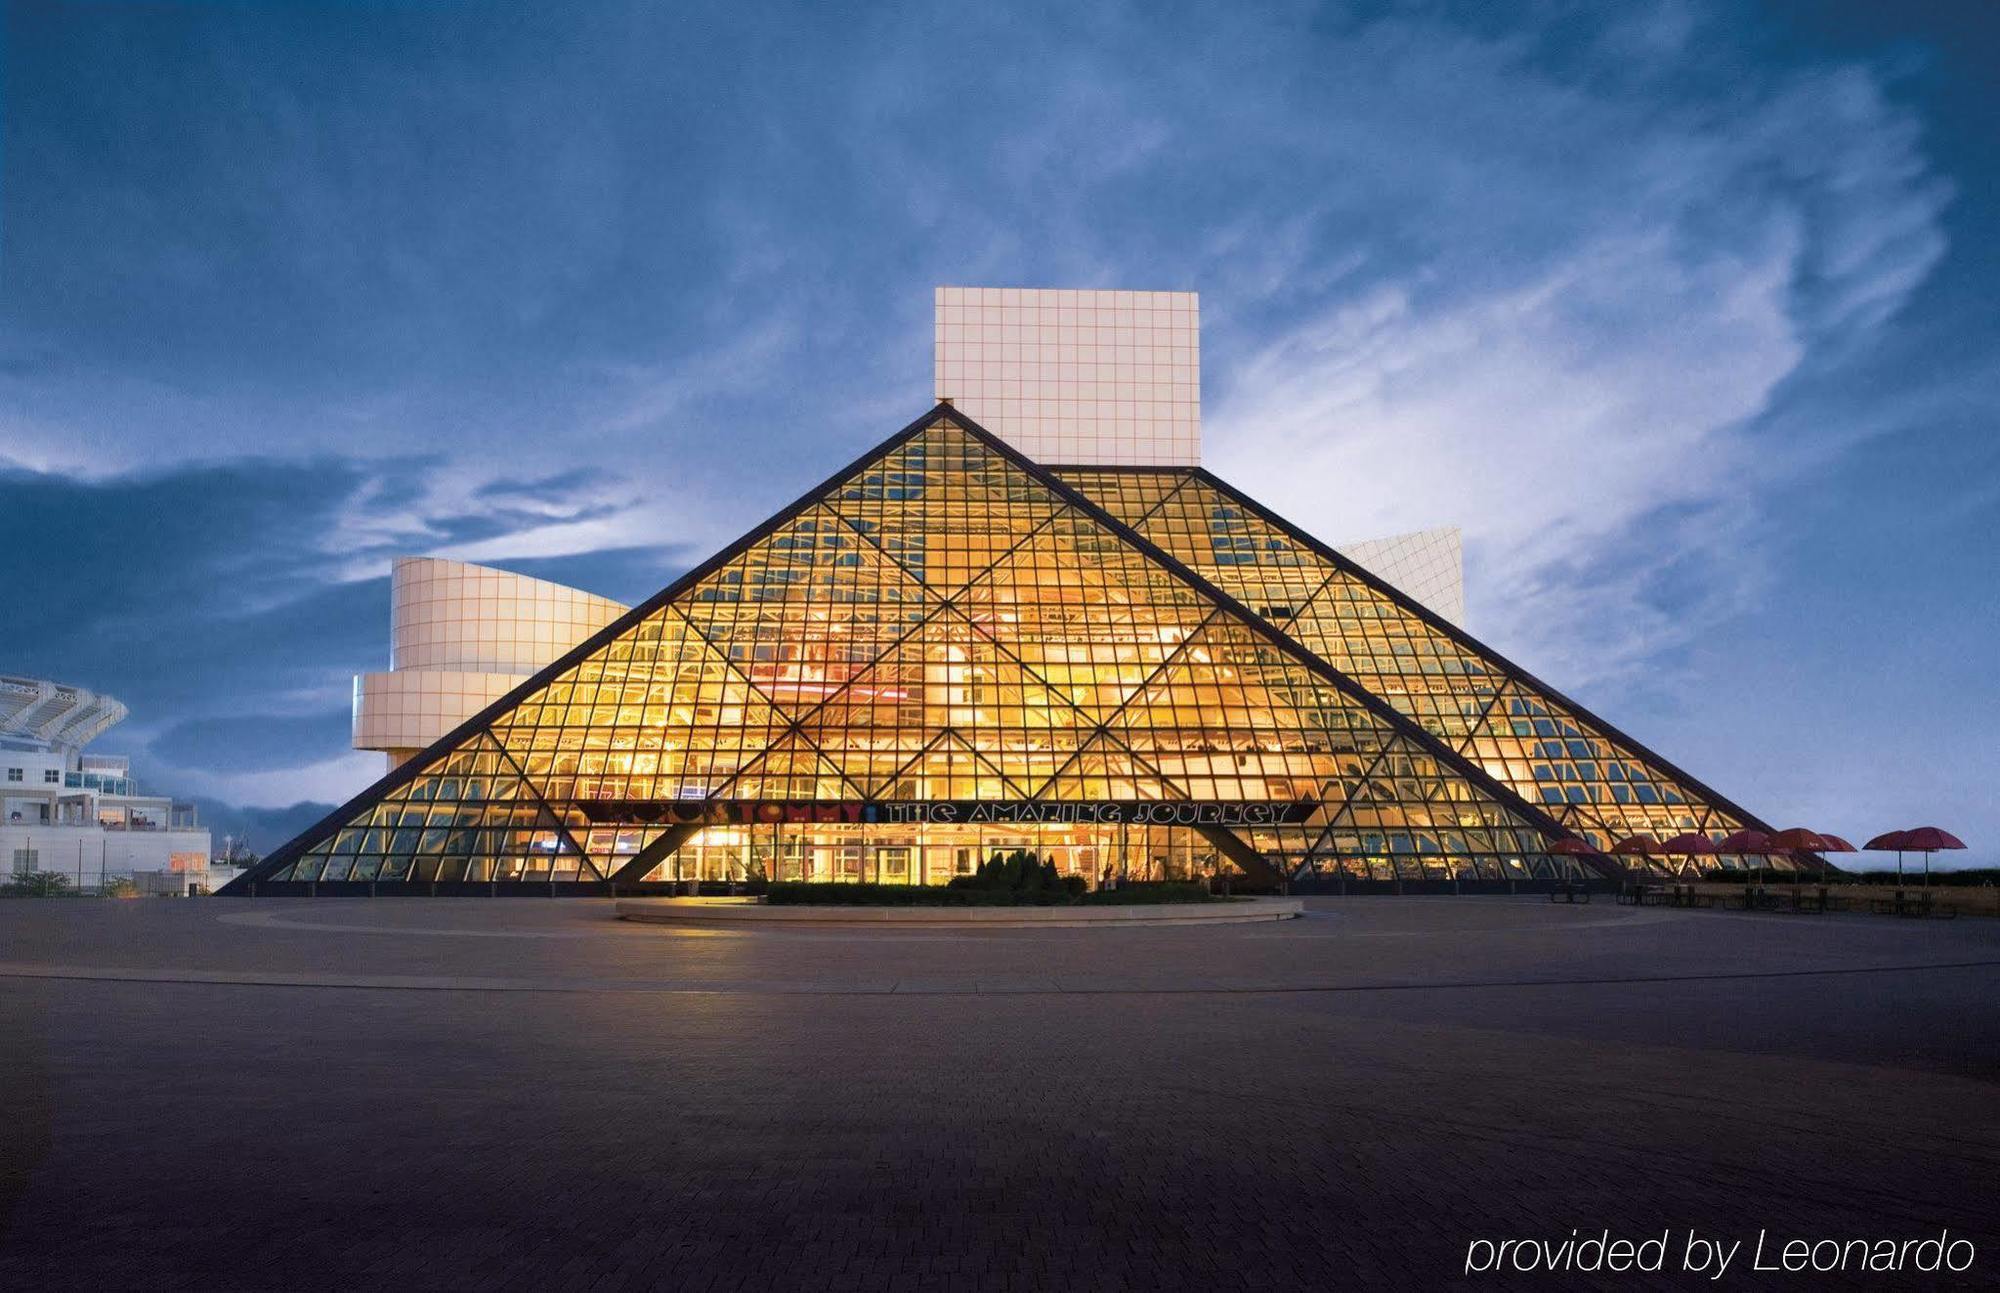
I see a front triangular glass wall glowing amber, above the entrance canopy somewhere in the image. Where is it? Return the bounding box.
[246,406,1558,881]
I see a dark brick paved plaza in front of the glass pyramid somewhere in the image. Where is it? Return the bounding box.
[0,899,2000,1289]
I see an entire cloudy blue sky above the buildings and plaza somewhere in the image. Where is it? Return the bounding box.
[0,0,2000,863]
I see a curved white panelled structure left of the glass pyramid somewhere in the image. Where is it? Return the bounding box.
[354,556,626,763]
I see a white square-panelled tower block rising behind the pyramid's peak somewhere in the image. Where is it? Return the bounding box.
[934,288,1202,466]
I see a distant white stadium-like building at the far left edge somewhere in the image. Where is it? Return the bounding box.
[0,675,215,893]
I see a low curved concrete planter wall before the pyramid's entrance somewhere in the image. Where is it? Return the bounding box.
[618,899,1304,929]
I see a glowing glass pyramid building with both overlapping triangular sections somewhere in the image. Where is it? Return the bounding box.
[230,402,1792,893]
